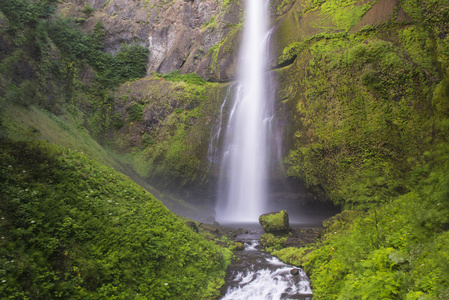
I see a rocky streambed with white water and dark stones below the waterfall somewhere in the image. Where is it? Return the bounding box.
[196,223,322,300]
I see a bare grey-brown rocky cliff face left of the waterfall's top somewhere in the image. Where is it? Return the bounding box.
[58,0,243,81]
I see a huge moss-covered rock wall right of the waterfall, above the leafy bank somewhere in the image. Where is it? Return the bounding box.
[277,1,449,206]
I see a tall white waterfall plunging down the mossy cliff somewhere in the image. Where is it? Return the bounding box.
[216,0,273,222]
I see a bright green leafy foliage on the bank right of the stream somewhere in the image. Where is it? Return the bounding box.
[274,146,449,300]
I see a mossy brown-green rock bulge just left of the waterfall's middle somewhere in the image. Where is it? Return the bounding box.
[112,77,225,186]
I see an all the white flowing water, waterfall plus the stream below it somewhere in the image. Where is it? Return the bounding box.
[208,0,312,300]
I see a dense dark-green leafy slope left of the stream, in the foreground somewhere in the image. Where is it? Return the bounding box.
[0,140,230,299]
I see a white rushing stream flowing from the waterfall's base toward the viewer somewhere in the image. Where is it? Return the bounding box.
[220,224,312,300]
